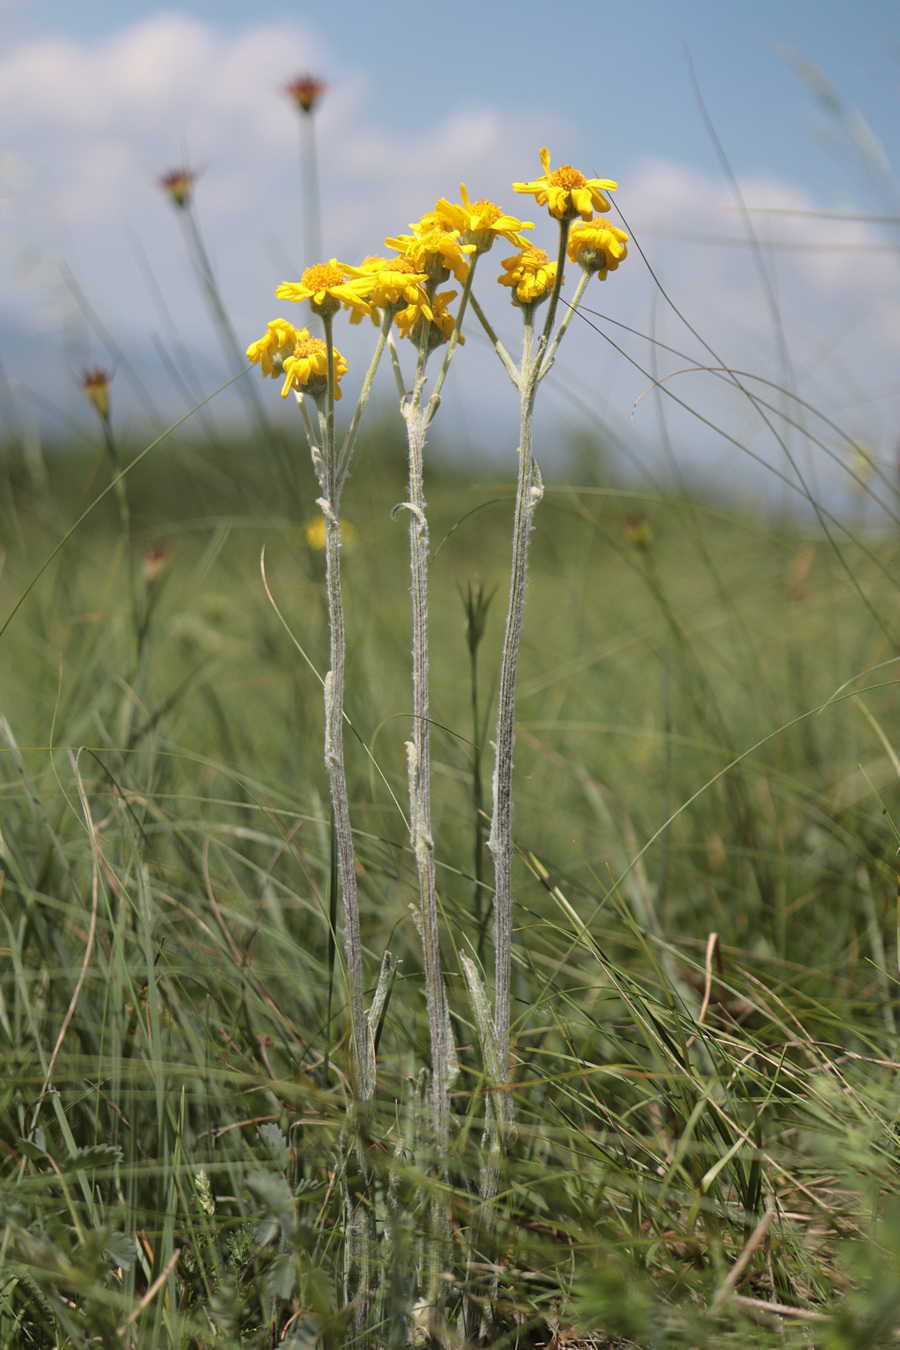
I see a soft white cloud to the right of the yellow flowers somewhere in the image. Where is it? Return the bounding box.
[621,163,900,394]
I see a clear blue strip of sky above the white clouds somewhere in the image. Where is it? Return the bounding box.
[8,0,900,188]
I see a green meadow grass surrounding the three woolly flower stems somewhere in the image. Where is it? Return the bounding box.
[0,423,900,1350]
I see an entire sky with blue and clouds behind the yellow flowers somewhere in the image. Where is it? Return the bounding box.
[0,0,900,496]
